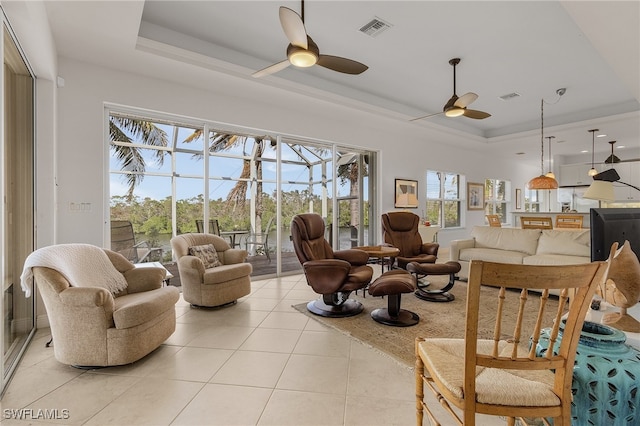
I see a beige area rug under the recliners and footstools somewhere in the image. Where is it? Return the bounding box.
[294,276,558,367]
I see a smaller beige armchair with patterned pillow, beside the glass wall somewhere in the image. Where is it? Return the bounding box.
[171,234,253,307]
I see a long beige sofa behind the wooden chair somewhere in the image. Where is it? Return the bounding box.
[449,226,591,279]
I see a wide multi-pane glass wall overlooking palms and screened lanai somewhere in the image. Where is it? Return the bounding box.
[108,110,376,276]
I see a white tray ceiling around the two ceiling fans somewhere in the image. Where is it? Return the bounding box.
[45,0,640,166]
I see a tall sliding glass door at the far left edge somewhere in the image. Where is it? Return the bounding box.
[0,19,36,391]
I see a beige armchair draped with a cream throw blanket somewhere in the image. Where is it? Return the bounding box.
[23,244,180,367]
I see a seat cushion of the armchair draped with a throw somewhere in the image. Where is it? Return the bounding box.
[113,287,180,329]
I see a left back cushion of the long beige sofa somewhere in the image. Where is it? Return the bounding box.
[471,226,541,255]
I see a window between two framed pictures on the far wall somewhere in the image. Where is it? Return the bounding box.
[422,170,463,229]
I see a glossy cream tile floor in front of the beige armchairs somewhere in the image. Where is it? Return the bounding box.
[0,275,504,426]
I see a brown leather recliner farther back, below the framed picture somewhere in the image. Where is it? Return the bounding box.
[382,212,440,269]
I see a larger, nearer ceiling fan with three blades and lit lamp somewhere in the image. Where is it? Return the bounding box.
[252,0,369,77]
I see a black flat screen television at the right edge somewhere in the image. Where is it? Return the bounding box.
[590,208,640,261]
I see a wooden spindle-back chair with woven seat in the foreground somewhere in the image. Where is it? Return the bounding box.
[415,260,609,426]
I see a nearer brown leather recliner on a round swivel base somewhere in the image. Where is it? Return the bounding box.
[291,213,373,317]
